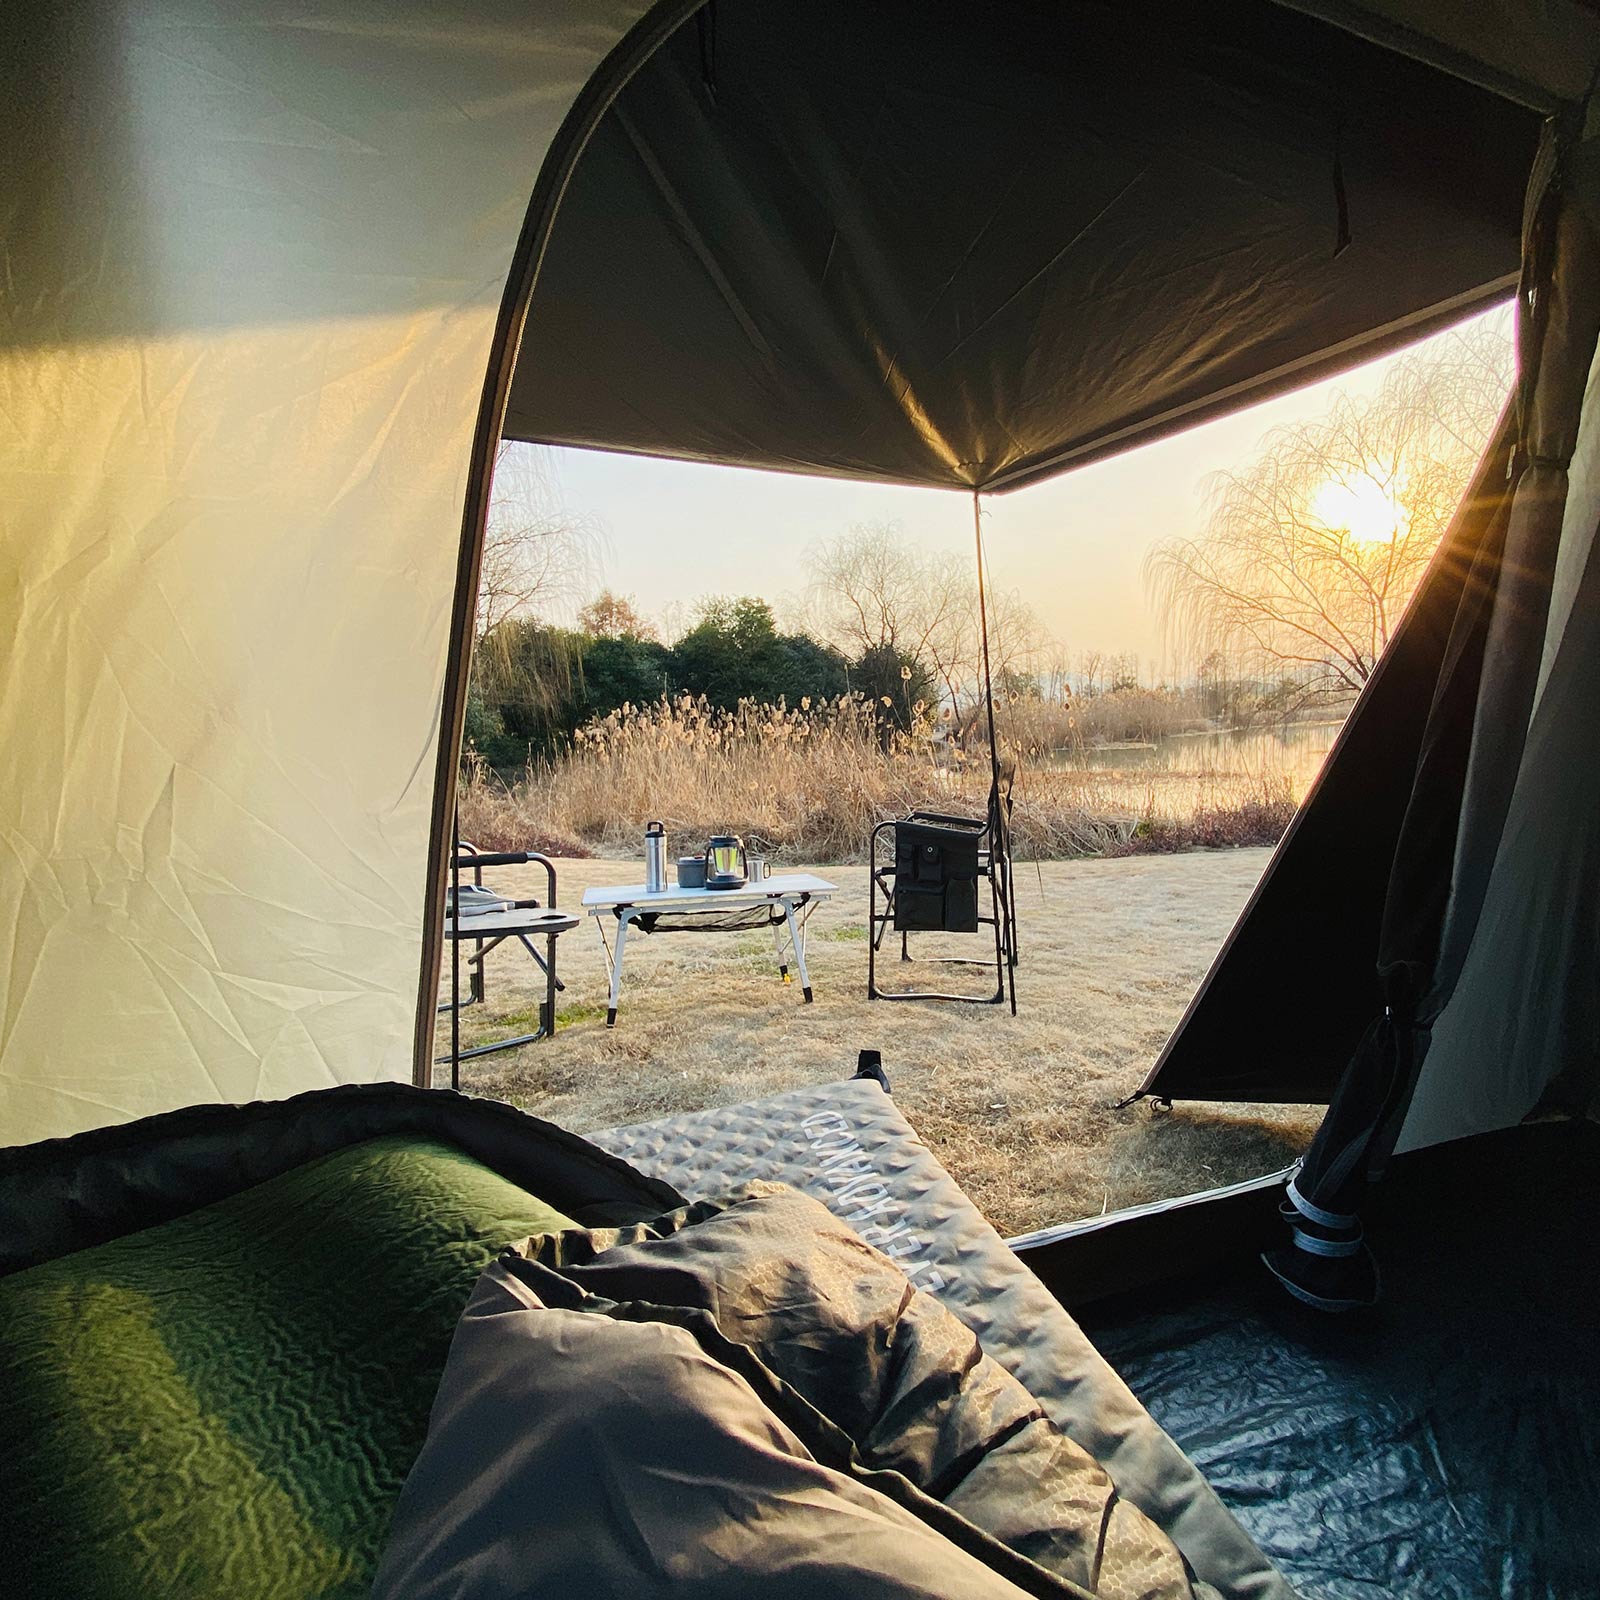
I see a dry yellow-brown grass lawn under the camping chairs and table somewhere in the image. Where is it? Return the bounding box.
[440,850,1317,1234]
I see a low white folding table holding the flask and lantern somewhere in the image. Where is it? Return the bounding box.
[584,872,838,1027]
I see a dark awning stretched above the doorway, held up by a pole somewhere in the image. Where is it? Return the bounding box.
[506,0,1538,490]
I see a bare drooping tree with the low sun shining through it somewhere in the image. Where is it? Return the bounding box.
[1146,317,1514,693]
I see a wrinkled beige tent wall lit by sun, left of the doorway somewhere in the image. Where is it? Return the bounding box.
[0,0,645,1142]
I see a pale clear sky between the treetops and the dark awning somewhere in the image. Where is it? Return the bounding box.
[517,312,1494,680]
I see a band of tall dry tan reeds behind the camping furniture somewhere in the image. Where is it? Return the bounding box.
[461,696,1293,862]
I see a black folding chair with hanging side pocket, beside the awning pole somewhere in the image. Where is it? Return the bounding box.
[867,781,1018,1016]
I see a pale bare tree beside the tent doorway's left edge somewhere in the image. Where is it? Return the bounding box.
[477,442,600,638]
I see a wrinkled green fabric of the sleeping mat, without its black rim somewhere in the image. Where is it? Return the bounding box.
[0,1134,573,1600]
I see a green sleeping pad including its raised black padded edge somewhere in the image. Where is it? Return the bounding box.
[0,1085,678,1600]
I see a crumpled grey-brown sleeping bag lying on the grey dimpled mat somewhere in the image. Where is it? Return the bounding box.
[374,1186,1213,1600]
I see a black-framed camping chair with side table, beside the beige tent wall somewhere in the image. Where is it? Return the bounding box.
[435,838,579,1088]
